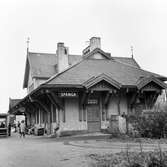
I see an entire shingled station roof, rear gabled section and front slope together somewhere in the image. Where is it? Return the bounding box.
[23,49,166,88]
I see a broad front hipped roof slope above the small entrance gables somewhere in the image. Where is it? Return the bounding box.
[45,59,167,86]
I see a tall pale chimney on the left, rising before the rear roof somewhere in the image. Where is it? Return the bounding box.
[56,42,68,72]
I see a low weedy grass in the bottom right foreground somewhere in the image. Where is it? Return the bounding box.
[89,143,167,167]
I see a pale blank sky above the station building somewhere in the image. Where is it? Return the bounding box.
[0,0,167,112]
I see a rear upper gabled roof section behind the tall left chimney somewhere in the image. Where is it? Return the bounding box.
[23,52,81,88]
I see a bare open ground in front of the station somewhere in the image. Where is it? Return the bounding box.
[0,134,167,167]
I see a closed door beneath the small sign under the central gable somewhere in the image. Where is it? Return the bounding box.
[87,105,100,132]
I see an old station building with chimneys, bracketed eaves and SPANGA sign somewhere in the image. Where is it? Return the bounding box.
[9,37,167,134]
